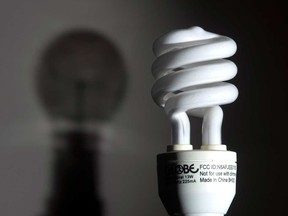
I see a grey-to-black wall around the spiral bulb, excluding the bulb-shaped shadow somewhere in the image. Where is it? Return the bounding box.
[0,0,288,216]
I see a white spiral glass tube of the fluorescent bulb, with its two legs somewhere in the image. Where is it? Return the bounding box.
[152,26,238,145]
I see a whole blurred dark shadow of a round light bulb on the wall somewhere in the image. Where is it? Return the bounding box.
[35,29,127,216]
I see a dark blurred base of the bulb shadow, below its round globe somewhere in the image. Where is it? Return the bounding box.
[46,130,103,216]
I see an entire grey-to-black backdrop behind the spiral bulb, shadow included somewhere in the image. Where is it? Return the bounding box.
[0,0,288,216]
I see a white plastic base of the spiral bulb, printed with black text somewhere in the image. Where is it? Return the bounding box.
[157,145,237,216]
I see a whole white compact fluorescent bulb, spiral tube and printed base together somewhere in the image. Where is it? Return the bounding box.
[152,27,238,216]
